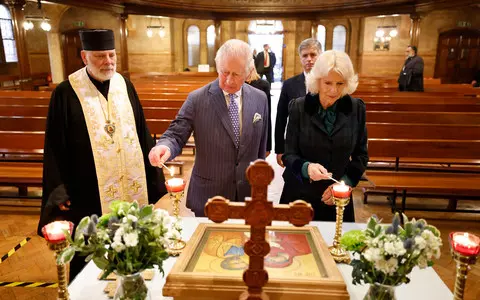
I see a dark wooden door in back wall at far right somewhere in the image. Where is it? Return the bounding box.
[435,28,480,83]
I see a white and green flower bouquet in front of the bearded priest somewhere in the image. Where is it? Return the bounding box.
[57,201,181,278]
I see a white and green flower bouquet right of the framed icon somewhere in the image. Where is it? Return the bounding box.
[341,214,442,286]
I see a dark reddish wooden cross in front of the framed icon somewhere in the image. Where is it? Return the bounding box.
[205,159,313,300]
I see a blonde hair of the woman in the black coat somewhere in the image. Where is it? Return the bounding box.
[307,50,358,96]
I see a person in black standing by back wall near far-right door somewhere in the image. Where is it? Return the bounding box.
[398,46,423,92]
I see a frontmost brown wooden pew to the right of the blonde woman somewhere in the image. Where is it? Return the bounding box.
[364,138,480,212]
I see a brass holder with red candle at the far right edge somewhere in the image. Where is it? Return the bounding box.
[449,232,480,300]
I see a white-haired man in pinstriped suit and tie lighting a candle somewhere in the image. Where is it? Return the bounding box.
[149,40,268,216]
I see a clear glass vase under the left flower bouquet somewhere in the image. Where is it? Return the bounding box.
[113,272,151,300]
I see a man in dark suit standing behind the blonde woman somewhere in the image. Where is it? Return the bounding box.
[275,38,322,167]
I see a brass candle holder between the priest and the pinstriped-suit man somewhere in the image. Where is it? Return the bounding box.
[166,178,186,256]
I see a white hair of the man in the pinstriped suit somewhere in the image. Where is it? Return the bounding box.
[215,39,253,76]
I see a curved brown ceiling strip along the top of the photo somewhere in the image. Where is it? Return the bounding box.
[40,0,478,20]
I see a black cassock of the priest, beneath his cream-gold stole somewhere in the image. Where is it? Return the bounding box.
[38,75,167,235]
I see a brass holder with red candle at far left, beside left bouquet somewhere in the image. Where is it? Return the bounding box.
[42,221,73,300]
